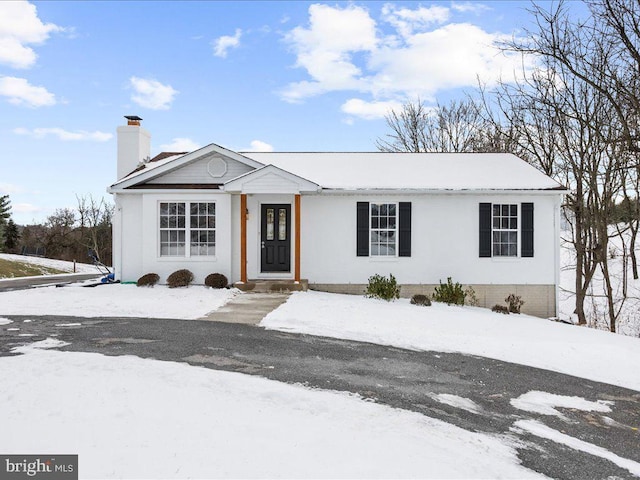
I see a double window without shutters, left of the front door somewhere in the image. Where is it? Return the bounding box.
[160,202,216,257]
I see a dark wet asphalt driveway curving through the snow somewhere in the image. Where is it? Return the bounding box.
[0,316,640,479]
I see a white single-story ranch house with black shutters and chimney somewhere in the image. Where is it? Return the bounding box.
[108,117,565,317]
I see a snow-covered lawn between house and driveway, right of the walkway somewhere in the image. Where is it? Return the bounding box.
[260,291,640,391]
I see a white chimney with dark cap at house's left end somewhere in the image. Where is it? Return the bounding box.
[117,115,151,180]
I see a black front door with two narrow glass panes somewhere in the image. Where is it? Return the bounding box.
[260,204,291,272]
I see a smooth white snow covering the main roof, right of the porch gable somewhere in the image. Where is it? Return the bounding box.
[241,152,563,190]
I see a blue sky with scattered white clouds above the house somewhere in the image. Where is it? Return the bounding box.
[0,1,556,224]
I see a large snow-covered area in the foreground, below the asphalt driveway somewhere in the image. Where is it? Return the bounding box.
[0,341,544,478]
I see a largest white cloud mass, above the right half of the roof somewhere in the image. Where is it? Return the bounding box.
[280,3,533,110]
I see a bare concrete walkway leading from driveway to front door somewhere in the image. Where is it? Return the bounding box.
[200,292,291,325]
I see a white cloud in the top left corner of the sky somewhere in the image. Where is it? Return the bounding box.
[0,1,64,68]
